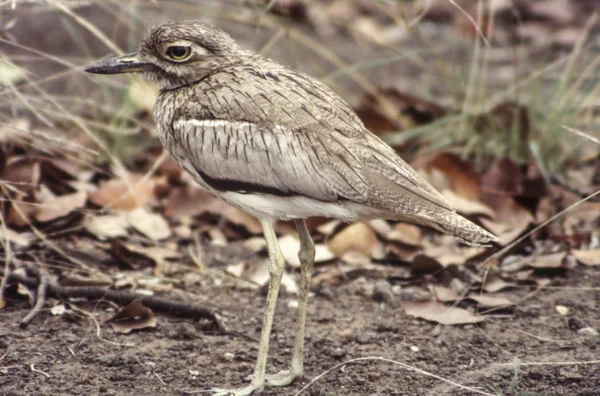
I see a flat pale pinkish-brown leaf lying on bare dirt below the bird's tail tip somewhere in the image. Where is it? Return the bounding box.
[404,301,485,325]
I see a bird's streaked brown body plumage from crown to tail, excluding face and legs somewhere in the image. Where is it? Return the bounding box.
[149,22,495,244]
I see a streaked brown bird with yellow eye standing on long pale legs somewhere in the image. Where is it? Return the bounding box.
[85,21,497,396]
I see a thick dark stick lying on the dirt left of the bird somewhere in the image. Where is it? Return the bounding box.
[1,273,228,331]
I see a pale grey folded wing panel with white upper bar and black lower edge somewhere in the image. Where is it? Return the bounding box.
[173,119,367,202]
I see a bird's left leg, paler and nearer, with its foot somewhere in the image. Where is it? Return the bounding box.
[212,220,285,396]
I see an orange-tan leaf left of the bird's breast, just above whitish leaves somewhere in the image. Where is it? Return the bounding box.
[90,173,154,211]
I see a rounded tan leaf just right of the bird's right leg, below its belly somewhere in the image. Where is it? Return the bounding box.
[327,223,380,257]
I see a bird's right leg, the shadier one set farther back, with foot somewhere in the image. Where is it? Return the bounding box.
[267,220,315,386]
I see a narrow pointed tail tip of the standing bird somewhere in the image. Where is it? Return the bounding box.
[430,211,498,246]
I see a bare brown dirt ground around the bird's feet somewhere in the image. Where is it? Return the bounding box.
[0,248,600,396]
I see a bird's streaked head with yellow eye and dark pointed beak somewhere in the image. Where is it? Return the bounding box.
[85,21,248,88]
